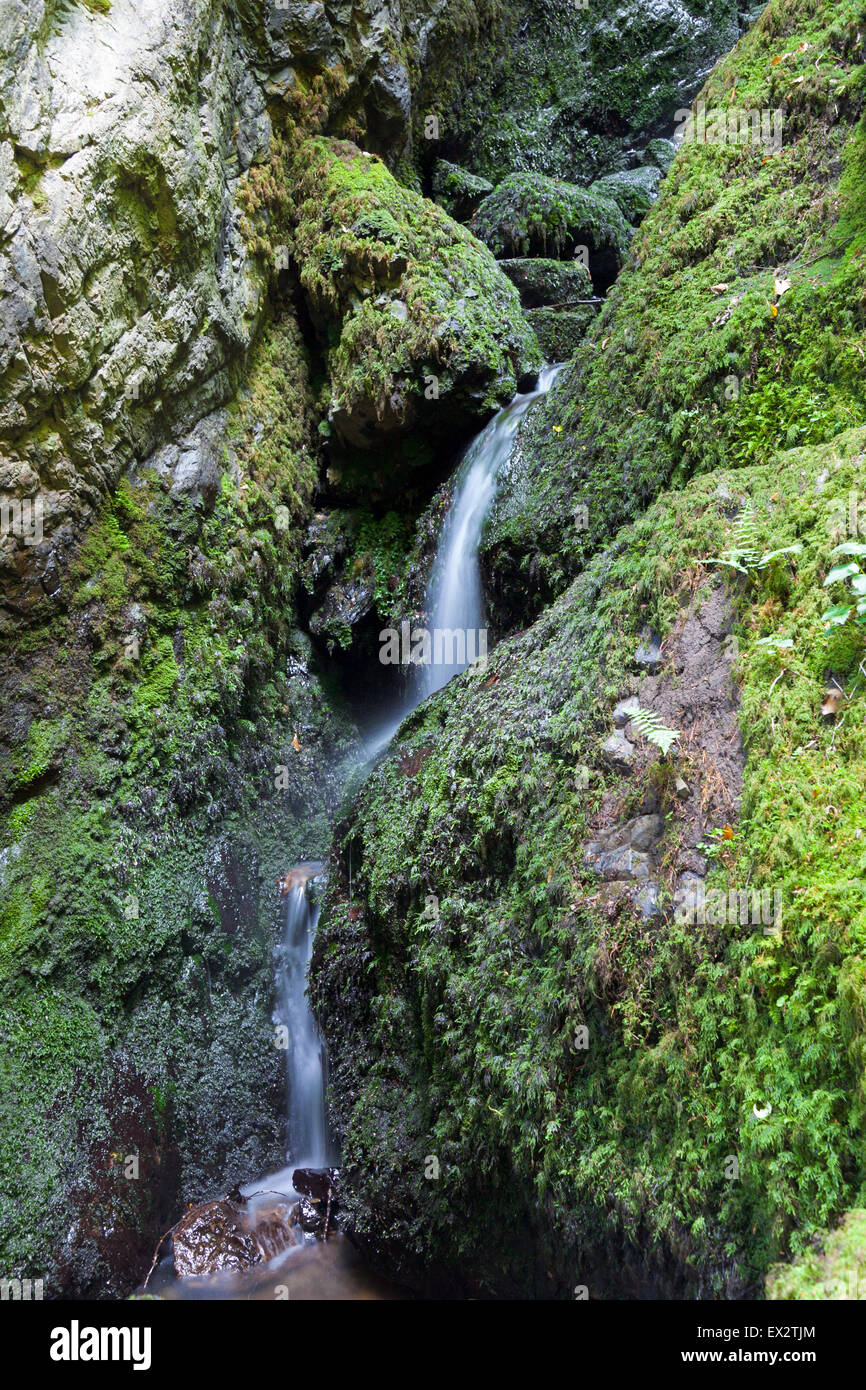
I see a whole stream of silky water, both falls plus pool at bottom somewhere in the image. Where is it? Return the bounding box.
[156,364,562,1300]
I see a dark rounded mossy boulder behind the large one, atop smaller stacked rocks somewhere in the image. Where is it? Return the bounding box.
[473,174,631,289]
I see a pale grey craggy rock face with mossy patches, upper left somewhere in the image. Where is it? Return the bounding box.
[0,0,270,625]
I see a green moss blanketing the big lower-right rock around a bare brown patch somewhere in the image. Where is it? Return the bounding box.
[313,430,866,1297]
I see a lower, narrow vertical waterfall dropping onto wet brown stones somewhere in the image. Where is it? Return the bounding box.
[274,865,329,1168]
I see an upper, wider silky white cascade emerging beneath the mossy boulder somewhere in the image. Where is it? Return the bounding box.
[422,364,562,705]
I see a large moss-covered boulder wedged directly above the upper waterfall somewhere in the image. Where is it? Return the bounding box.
[293,139,541,449]
